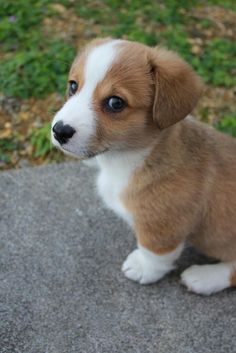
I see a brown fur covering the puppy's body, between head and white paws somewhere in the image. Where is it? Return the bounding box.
[122,120,236,261]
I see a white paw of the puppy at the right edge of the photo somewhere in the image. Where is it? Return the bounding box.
[181,263,235,295]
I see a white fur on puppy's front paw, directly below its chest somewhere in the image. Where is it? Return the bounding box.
[122,244,183,284]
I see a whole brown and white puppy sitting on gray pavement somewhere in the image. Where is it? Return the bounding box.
[52,39,236,295]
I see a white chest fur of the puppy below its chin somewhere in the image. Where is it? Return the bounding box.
[97,150,149,226]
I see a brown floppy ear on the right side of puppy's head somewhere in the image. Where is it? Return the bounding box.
[148,48,202,129]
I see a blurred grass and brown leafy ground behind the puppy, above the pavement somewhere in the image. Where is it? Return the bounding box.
[0,0,236,169]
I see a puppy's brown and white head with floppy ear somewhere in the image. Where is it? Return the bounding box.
[52,39,201,158]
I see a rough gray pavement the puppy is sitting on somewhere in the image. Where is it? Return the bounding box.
[0,162,236,353]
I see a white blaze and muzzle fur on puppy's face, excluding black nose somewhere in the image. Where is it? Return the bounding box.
[52,40,120,157]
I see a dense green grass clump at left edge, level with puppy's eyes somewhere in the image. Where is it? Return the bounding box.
[0,40,75,98]
